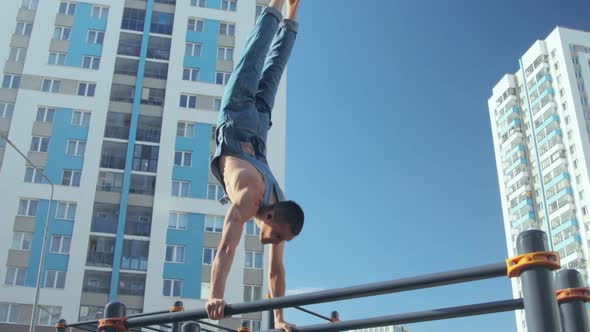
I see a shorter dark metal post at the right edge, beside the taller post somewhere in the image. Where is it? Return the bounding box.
[555,269,590,332]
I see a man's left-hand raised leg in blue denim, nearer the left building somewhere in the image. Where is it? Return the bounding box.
[221,0,285,110]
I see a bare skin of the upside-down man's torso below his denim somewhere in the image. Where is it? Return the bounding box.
[219,155,277,219]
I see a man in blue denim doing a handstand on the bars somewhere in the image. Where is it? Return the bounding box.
[206,0,303,332]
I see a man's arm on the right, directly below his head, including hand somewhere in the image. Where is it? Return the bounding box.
[268,241,292,332]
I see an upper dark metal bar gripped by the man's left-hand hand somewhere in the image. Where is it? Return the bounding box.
[125,262,506,328]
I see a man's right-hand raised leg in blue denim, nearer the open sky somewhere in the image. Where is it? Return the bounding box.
[256,0,299,113]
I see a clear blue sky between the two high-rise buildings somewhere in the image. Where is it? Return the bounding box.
[276,0,590,332]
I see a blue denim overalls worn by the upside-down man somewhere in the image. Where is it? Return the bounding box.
[211,7,298,206]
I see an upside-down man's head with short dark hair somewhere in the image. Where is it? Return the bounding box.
[260,201,303,244]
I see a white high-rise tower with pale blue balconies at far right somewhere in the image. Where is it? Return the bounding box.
[488,27,590,331]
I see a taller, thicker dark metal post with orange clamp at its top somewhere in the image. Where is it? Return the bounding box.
[516,229,559,332]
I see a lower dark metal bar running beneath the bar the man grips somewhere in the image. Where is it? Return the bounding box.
[265,299,524,332]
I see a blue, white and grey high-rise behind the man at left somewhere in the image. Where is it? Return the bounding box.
[0,0,286,331]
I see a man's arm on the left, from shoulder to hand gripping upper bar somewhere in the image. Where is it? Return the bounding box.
[205,189,258,319]
